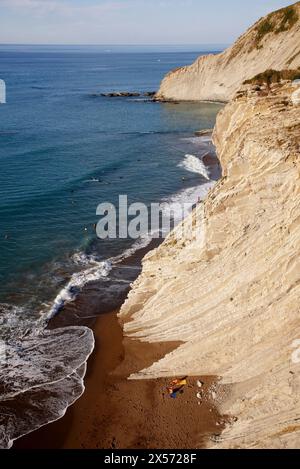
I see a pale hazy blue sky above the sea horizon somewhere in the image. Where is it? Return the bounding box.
[0,0,293,45]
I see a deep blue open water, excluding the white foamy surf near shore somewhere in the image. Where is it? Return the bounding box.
[0,46,220,306]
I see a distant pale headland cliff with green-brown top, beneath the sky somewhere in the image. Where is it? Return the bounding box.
[156,2,300,101]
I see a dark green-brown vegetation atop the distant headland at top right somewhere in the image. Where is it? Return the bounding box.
[254,5,299,49]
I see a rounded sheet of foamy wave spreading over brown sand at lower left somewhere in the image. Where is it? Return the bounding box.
[0,327,95,448]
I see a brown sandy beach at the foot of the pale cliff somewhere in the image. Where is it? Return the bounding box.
[15,313,222,449]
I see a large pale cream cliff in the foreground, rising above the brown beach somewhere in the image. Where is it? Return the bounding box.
[120,82,300,448]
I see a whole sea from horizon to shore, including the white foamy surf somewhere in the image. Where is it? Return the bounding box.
[0,45,222,448]
